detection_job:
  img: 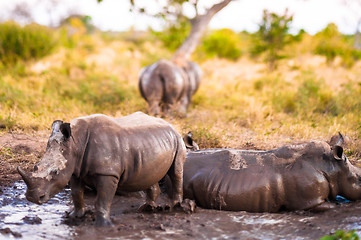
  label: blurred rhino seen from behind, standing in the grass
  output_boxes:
[139,59,202,116]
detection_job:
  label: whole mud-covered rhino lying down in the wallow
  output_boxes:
[183,135,361,212]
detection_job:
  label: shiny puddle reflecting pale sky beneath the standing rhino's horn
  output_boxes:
[0,182,73,239]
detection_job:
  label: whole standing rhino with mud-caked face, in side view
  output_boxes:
[18,112,186,226]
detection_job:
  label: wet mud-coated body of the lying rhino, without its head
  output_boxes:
[184,143,329,212]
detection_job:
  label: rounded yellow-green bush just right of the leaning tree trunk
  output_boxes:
[202,29,241,60]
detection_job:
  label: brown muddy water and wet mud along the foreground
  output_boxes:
[0,182,361,240]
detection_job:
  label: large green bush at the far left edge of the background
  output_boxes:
[0,22,56,65]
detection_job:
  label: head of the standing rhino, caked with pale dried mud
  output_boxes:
[17,120,74,204]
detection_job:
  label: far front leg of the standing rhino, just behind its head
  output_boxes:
[69,176,85,218]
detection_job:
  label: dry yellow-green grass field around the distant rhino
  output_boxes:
[0,28,361,161]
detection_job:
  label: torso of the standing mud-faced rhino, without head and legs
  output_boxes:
[71,112,185,191]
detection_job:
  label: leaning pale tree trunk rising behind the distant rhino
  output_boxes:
[172,0,232,67]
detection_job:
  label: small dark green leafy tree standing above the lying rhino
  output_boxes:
[251,10,293,70]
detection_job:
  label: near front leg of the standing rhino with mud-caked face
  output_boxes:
[95,175,118,226]
